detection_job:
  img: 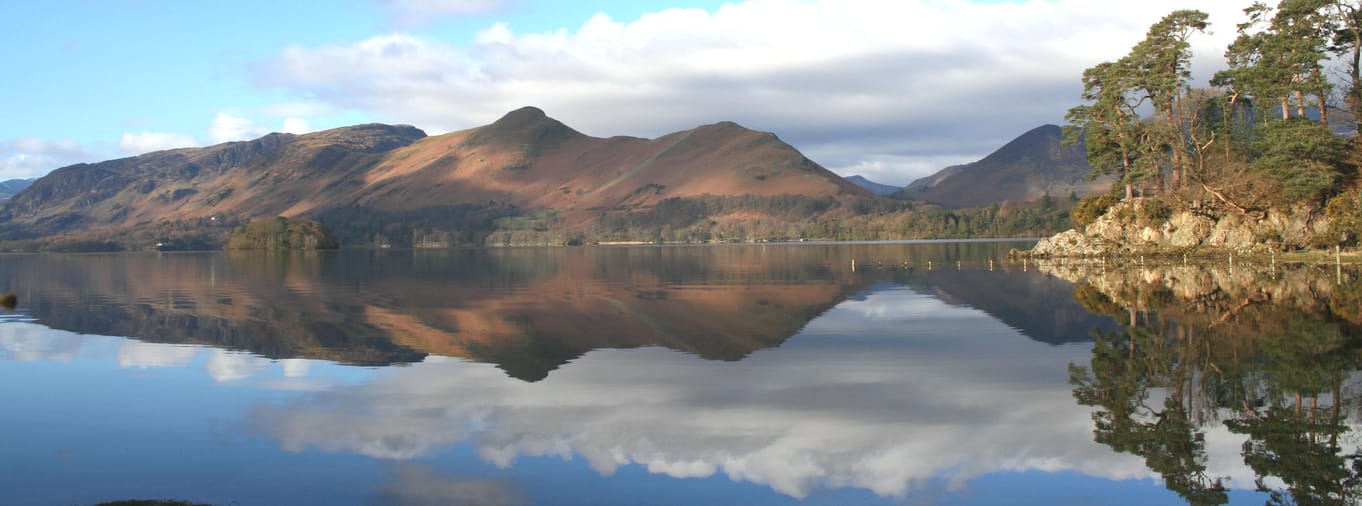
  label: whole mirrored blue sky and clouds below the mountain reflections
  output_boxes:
[0,243,1307,505]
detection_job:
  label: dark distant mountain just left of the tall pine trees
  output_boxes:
[903,125,1111,208]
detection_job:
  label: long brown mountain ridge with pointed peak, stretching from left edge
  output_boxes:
[0,107,870,245]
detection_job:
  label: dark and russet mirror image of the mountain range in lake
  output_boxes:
[0,243,1089,381]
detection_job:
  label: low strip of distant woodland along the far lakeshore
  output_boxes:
[319,195,1079,248]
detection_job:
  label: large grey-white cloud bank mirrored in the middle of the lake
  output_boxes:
[253,290,1176,496]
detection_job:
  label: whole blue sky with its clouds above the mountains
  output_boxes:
[0,0,1250,185]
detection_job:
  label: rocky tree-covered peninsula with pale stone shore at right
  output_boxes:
[1027,3,1362,257]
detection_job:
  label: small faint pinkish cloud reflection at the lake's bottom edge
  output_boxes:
[373,464,530,506]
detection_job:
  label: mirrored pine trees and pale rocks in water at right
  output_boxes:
[1046,265,1362,505]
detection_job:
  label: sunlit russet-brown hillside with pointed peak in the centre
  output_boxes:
[332,107,868,223]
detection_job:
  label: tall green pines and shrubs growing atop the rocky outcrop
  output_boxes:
[1066,0,1362,248]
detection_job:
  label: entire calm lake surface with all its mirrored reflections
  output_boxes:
[0,241,1362,505]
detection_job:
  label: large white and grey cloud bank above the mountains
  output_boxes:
[259,0,1244,182]
